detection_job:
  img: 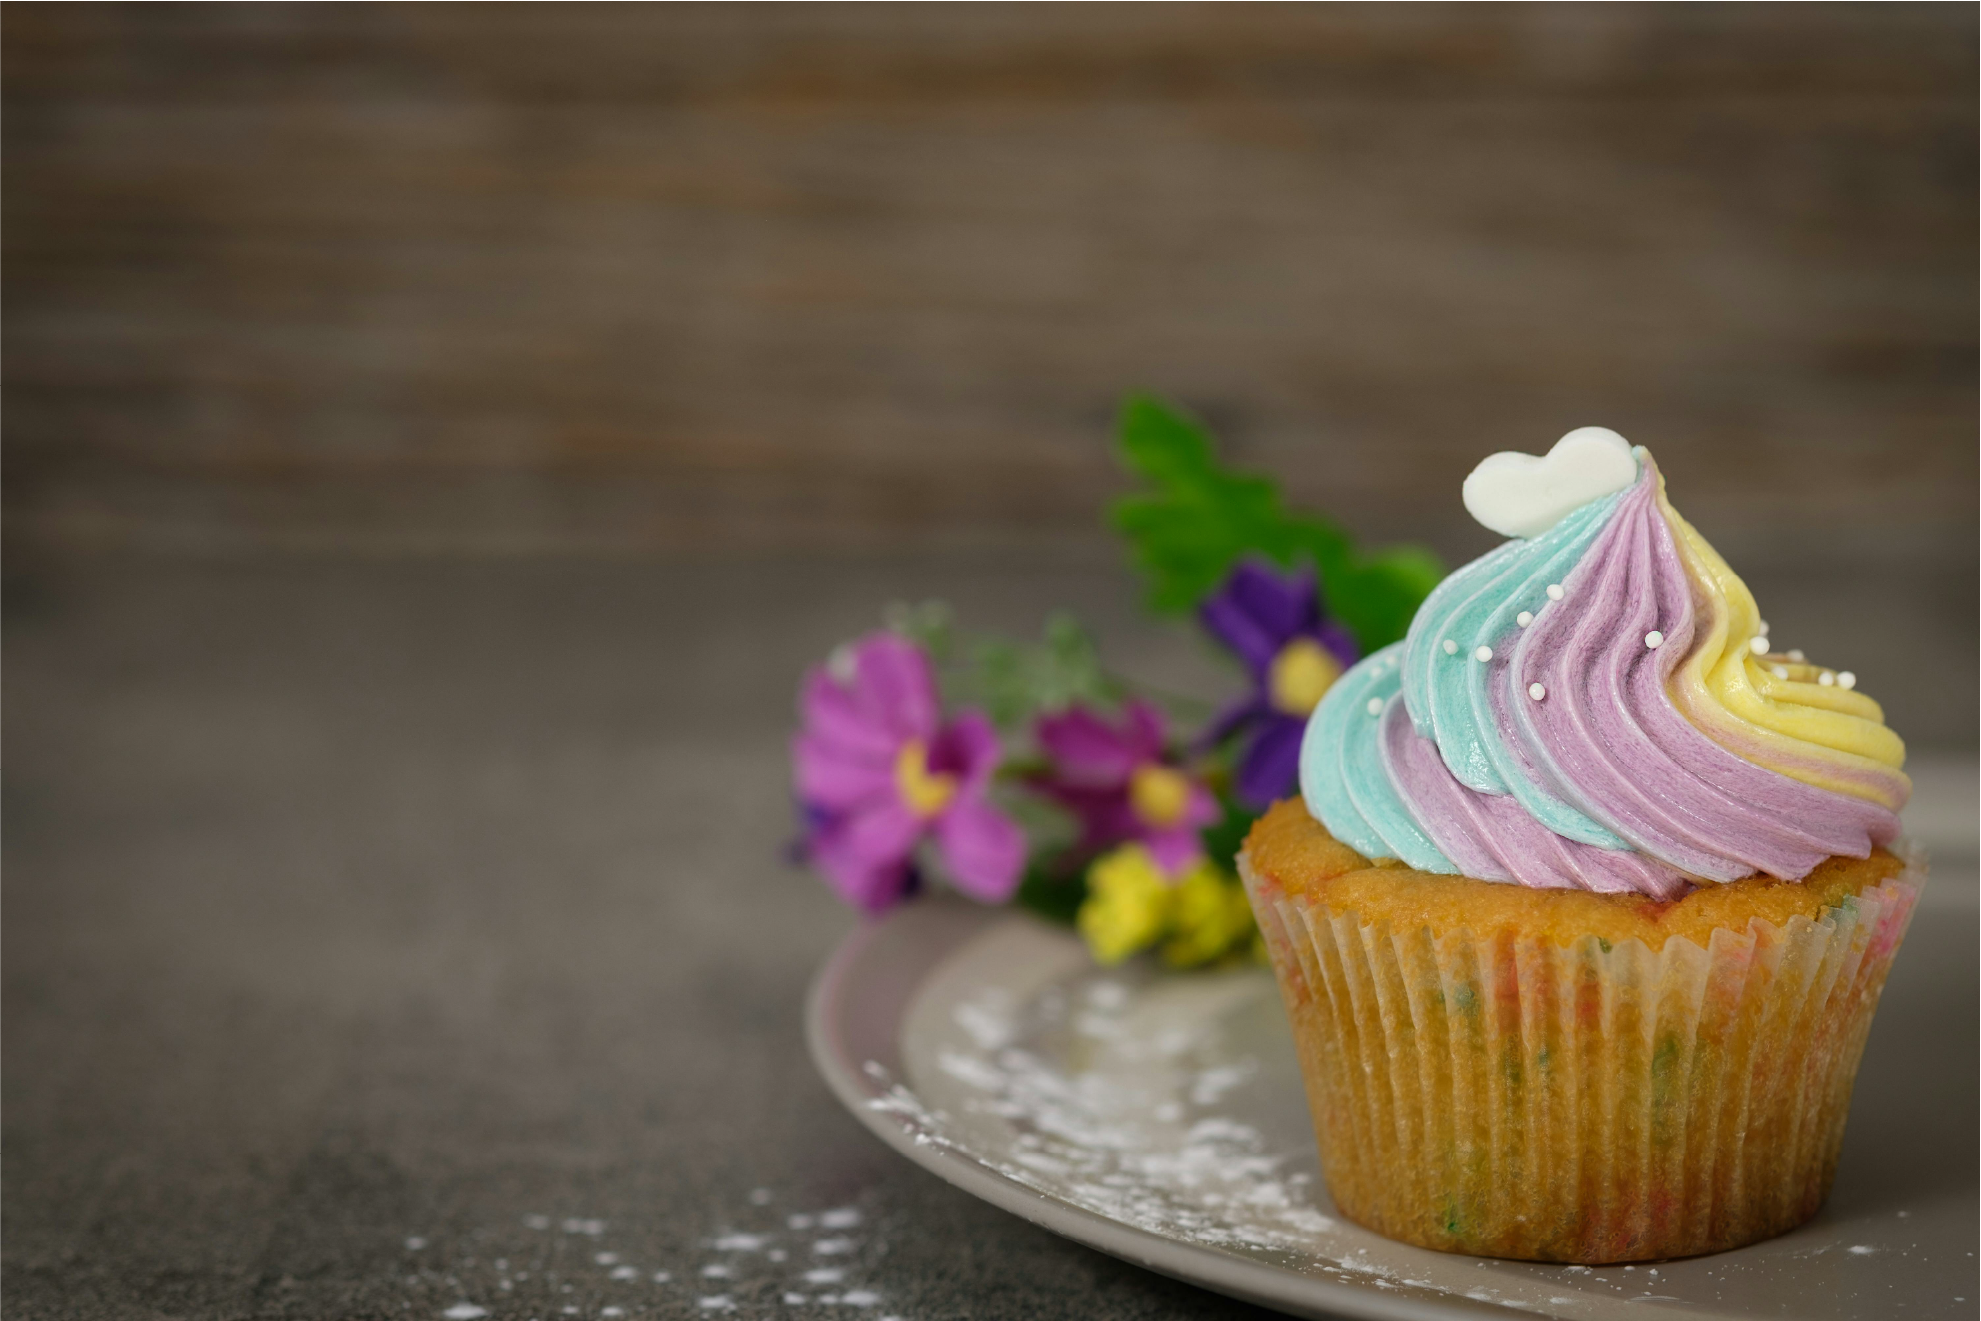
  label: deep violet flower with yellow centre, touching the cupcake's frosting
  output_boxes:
[1197,560,1361,810]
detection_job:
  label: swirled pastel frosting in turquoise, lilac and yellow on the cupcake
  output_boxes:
[1300,442,1912,897]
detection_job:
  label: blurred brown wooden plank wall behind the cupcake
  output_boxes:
[0,4,1977,625]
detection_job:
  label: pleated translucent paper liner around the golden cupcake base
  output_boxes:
[1238,858,1924,1264]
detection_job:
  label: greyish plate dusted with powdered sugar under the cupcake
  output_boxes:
[806,875,1977,1321]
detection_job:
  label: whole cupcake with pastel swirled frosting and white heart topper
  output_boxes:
[1240,428,1924,1264]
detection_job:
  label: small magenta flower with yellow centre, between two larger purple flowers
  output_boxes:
[1032,701,1218,875]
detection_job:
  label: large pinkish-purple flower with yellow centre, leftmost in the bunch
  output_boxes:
[790,634,1024,911]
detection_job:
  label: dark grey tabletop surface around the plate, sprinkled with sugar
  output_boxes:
[0,559,1973,1321]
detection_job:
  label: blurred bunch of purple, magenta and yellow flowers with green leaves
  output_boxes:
[790,396,1442,968]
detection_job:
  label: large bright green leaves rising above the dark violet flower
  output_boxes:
[1109,394,1444,652]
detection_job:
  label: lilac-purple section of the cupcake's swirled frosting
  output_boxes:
[1377,457,1900,897]
